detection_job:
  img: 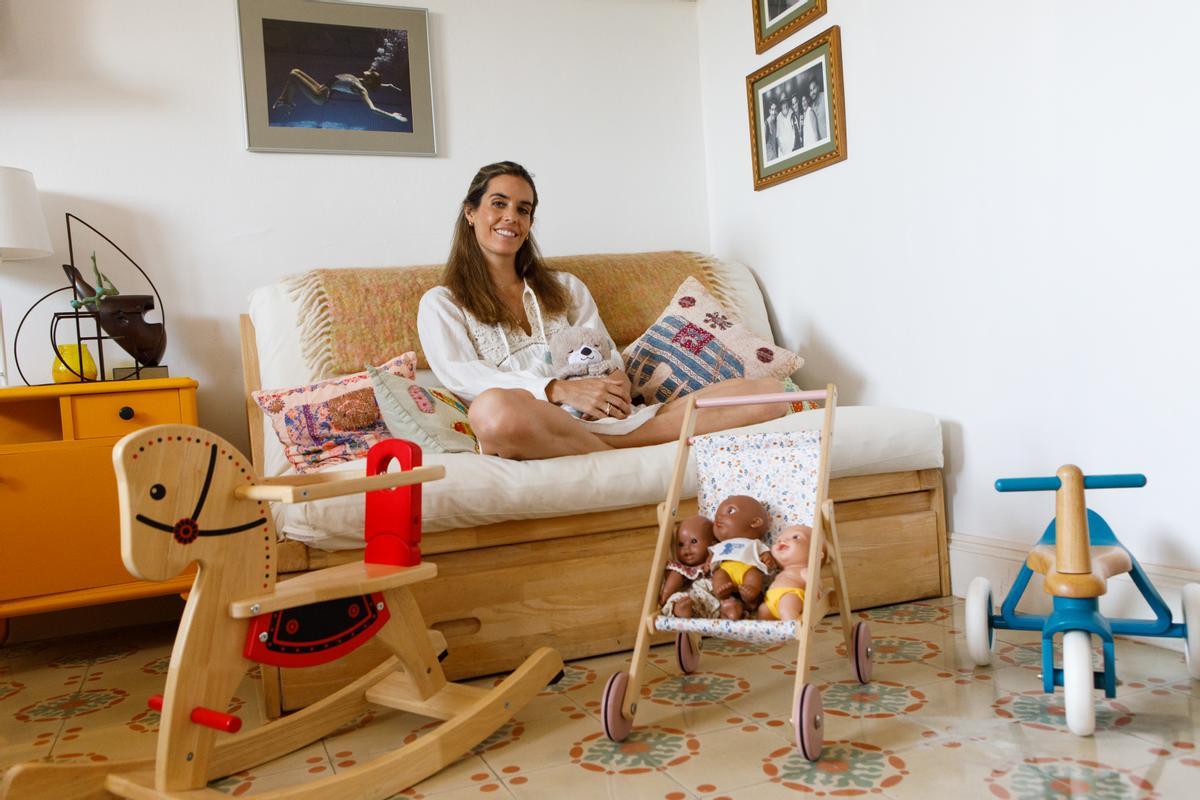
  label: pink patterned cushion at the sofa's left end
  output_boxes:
[253,353,416,473]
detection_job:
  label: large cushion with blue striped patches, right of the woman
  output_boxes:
[622,277,804,403]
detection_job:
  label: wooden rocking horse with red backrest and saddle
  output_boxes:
[0,425,563,800]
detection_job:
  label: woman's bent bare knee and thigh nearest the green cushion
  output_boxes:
[467,389,614,459]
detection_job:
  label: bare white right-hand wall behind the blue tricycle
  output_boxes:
[697,0,1200,567]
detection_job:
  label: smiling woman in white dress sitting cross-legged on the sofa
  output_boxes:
[416,161,785,459]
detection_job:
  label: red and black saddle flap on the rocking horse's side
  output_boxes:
[244,593,390,667]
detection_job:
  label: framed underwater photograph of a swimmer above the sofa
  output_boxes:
[238,0,437,156]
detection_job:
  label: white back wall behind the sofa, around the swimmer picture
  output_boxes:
[0,0,708,444]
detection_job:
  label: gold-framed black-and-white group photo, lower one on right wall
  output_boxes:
[746,25,846,191]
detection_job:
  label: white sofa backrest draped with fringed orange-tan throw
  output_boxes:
[244,252,774,475]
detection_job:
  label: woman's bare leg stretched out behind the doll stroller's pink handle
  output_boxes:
[599,378,787,447]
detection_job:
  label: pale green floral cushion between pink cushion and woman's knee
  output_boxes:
[367,367,479,452]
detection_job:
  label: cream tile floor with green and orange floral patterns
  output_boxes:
[0,599,1200,800]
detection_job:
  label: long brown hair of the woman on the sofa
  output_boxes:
[442,161,570,327]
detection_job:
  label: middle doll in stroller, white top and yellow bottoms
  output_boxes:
[708,494,775,619]
